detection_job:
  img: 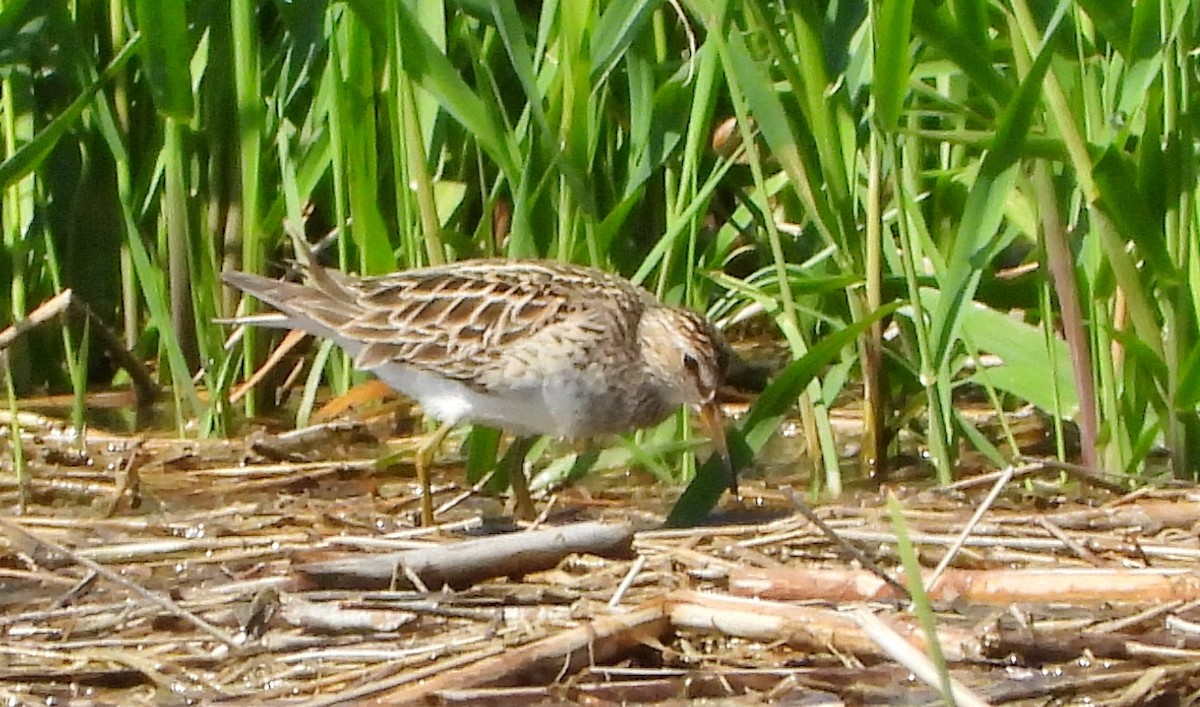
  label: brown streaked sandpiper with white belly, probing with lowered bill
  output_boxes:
[224,259,736,525]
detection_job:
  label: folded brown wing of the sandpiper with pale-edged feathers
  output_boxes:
[296,260,649,389]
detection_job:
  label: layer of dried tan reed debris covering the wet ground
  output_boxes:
[0,415,1200,705]
